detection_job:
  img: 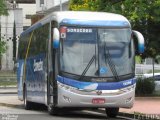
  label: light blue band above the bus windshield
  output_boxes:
[61,19,131,27]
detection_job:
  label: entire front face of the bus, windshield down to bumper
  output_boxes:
[57,19,135,107]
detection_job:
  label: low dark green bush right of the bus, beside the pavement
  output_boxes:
[136,78,155,96]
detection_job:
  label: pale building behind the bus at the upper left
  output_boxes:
[0,0,36,70]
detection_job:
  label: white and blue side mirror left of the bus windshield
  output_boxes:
[53,28,60,49]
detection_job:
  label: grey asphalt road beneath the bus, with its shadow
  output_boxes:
[0,94,133,120]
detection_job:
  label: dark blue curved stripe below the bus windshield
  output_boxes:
[57,76,136,90]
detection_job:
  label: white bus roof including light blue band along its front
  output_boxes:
[21,11,131,35]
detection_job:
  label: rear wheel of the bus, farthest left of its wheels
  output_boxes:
[23,87,32,110]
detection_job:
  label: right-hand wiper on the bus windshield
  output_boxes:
[104,43,119,81]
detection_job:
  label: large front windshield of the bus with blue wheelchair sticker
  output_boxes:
[60,27,134,80]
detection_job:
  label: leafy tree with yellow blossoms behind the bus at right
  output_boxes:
[70,0,160,58]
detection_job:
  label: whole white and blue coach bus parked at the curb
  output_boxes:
[17,11,144,117]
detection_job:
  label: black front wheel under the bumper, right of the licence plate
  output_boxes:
[106,108,119,118]
